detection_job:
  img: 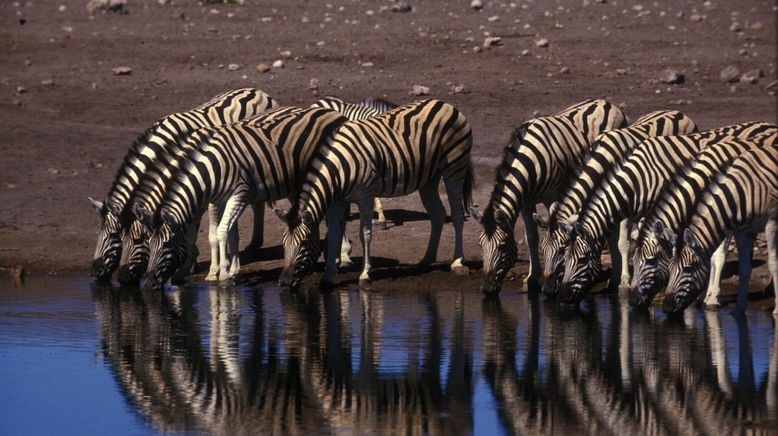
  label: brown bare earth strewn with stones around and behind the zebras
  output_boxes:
[0,0,778,305]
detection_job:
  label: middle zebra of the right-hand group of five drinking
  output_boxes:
[558,122,775,305]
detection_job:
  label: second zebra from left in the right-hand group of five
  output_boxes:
[533,111,697,296]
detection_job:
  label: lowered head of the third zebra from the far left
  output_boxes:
[148,211,188,288]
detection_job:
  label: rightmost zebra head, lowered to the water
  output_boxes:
[662,228,710,315]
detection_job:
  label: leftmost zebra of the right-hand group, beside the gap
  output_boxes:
[471,100,627,294]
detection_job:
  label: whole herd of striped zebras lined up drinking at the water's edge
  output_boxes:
[90,88,778,315]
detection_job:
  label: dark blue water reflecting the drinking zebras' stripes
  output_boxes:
[0,278,778,435]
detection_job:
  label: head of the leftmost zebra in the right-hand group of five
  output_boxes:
[470,208,518,295]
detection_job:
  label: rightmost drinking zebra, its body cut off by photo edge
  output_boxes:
[662,147,778,317]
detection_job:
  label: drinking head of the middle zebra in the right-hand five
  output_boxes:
[557,222,602,305]
